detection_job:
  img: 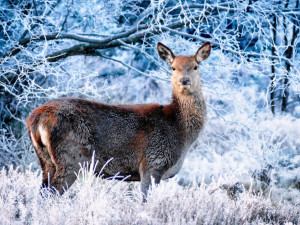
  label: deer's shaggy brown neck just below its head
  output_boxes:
[173,89,206,142]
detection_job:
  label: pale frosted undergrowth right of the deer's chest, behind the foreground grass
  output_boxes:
[178,114,300,206]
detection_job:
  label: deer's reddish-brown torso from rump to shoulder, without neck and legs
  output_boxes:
[27,98,183,180]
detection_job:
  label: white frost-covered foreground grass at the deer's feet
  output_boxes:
[0,163,300,224]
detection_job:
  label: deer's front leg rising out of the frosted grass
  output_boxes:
[139,159,163,202]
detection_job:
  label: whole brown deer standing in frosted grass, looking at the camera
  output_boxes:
[26,42,211,202]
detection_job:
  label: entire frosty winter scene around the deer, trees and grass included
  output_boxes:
[0,0,300,225]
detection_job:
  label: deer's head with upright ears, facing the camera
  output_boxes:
[157,42,211,95]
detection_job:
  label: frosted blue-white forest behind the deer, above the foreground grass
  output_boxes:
[0,0,300,224]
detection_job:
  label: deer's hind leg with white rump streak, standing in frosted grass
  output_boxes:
[36,123,91,194]
